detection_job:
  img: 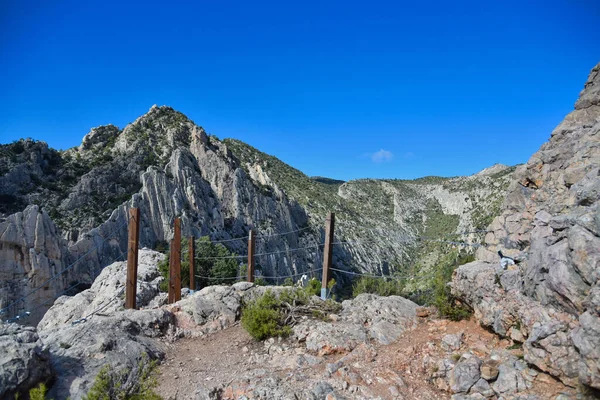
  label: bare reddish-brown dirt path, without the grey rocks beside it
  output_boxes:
[157,319,572,400]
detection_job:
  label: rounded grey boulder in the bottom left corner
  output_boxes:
[0,324,52,398]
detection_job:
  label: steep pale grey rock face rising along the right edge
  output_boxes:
[453,64,600,390]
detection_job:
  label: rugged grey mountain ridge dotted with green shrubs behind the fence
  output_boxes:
[0,106,514,321]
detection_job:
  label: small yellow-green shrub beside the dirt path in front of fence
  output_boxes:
[242,290,291,340]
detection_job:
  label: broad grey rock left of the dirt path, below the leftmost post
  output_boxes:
[40,310,168,399]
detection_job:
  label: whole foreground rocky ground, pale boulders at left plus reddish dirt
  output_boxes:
[0,249,584,400]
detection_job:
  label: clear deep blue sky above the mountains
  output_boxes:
[0,0,600,179]
